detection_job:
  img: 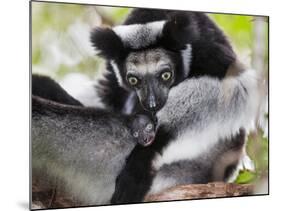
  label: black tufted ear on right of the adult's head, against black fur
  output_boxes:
[161,12,200,50]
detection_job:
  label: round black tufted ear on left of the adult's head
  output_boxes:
[91,27,124,60]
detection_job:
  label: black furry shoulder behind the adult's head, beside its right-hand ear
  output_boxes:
[164,12,236,78]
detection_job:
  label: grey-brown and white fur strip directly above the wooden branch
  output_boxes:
[144,129,245,196]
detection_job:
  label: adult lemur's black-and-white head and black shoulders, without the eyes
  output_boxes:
[91,9,236,113]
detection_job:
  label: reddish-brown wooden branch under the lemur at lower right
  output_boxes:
[145,182,253,201]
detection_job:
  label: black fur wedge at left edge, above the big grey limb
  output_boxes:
[32,74,82,106]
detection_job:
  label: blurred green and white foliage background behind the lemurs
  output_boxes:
[32,2,268,191]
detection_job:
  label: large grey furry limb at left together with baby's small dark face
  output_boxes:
[31,96,155,208]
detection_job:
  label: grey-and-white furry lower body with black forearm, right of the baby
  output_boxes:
[112,67,259,203]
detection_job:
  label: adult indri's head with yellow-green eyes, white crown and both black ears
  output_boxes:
[88,11,198,113]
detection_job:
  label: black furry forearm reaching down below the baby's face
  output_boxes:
[111,125,173,204]
